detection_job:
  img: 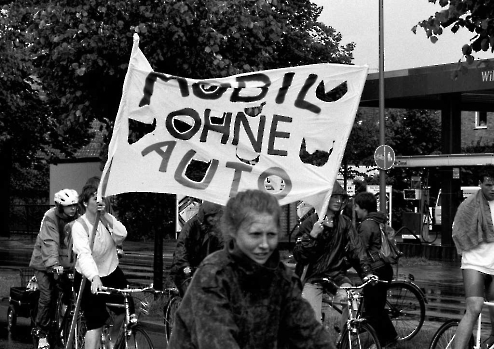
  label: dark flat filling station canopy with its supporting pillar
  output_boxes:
[360,59,494,246]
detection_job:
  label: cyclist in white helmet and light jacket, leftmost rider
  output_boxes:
[29,189,79,349]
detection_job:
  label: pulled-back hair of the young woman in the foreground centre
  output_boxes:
[221,190,281,241]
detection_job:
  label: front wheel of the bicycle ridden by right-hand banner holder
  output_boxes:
[338,322,381,349]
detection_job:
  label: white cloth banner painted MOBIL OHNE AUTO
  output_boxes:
[99,37,367,212]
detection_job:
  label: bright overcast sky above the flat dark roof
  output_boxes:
[312,0,494,72]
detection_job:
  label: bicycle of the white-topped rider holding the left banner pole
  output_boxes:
[98,285,161,349]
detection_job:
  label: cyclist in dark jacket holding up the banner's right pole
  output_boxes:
[293,181,370,326]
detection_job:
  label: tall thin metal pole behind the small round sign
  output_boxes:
[379,0,386,212]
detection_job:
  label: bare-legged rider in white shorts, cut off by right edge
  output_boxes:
[453,165,494,349]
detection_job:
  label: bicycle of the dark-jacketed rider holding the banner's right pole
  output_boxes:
[313,278,386,349]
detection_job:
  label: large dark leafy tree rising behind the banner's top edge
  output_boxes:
[0,0,354,237]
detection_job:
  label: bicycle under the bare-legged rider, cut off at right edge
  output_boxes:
[429,301,494,349]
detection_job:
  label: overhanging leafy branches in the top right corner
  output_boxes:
[412,0,494,69]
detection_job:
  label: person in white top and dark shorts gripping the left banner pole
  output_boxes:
[72,185,133,349]
